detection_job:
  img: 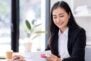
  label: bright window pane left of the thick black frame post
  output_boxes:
[0,0,11,57]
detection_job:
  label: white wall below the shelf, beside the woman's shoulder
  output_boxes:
[75,16,91,45]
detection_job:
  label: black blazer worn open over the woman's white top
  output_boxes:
[46,28,86,61]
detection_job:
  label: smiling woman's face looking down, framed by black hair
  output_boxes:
[52,8,69,29]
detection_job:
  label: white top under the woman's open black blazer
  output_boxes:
[58,28,70,59]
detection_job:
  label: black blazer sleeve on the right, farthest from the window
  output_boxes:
[62,29,86,61]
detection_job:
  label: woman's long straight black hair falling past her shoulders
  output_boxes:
[49,1,79,49]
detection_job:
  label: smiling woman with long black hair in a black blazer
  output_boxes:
[46,1,86,61]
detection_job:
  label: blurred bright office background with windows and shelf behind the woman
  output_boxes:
[0,0,91,60]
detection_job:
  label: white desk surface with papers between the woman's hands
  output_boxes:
[0,51,50,61]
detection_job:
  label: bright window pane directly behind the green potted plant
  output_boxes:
[19,0,45,52]
